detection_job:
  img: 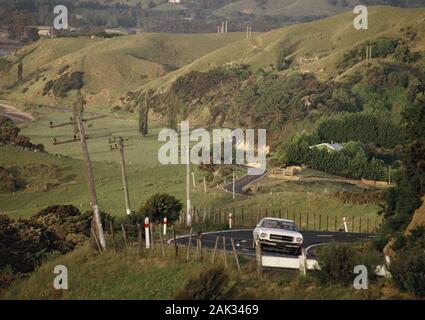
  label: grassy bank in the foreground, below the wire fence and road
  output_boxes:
[0,242,403,300]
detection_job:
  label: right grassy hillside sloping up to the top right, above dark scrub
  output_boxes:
[146,6,425,92]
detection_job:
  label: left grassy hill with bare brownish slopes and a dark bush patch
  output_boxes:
[0,33,245,110]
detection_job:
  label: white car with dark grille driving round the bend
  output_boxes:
[253,218,304,255]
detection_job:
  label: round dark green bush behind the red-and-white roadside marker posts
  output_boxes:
[138,193,183,223]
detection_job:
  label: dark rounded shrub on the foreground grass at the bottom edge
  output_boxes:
[175,266,234,300]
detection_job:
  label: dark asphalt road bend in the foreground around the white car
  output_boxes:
[171,229,374,258]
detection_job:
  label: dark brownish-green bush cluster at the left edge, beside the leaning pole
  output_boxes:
[0,205,110,287]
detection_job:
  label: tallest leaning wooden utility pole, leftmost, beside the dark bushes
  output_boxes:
[76,115,106,250]
